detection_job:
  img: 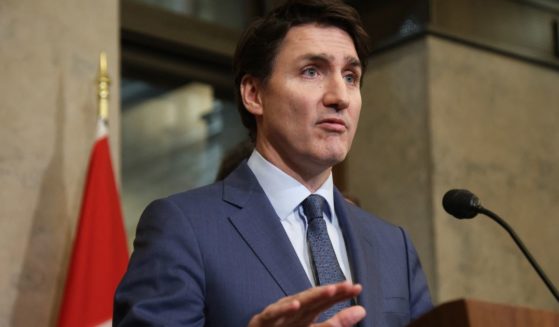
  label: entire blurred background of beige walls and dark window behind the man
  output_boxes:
[0,0,559,326]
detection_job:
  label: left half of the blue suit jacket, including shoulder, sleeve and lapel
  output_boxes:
[113,164,311,326]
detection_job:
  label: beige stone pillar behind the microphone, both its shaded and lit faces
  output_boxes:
[346,36,559,309]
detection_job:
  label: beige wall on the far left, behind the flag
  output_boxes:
[0,0,119,326]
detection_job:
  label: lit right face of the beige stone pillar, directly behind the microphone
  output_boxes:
[428,38,559,309]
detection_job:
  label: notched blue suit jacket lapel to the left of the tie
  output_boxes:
[223,162,312,295]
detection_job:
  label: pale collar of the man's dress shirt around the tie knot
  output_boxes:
[247,150,334,220]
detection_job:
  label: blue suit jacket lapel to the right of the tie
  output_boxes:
[334,189,383,327]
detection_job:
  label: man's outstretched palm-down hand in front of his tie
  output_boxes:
[249,282,364,327]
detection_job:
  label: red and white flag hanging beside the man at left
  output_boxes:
[58,119,128,327]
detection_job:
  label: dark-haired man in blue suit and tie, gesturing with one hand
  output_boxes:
[113,0,431,327]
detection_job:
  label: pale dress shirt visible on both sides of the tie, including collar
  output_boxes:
[247,150,352,285]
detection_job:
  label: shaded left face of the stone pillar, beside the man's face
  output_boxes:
[345,40,436,298]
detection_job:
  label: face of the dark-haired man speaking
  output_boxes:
[247,24,361,179]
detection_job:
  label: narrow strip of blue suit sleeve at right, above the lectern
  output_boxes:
[400,228,433,321]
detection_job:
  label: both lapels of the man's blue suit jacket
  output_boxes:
[223,162,383,327]
